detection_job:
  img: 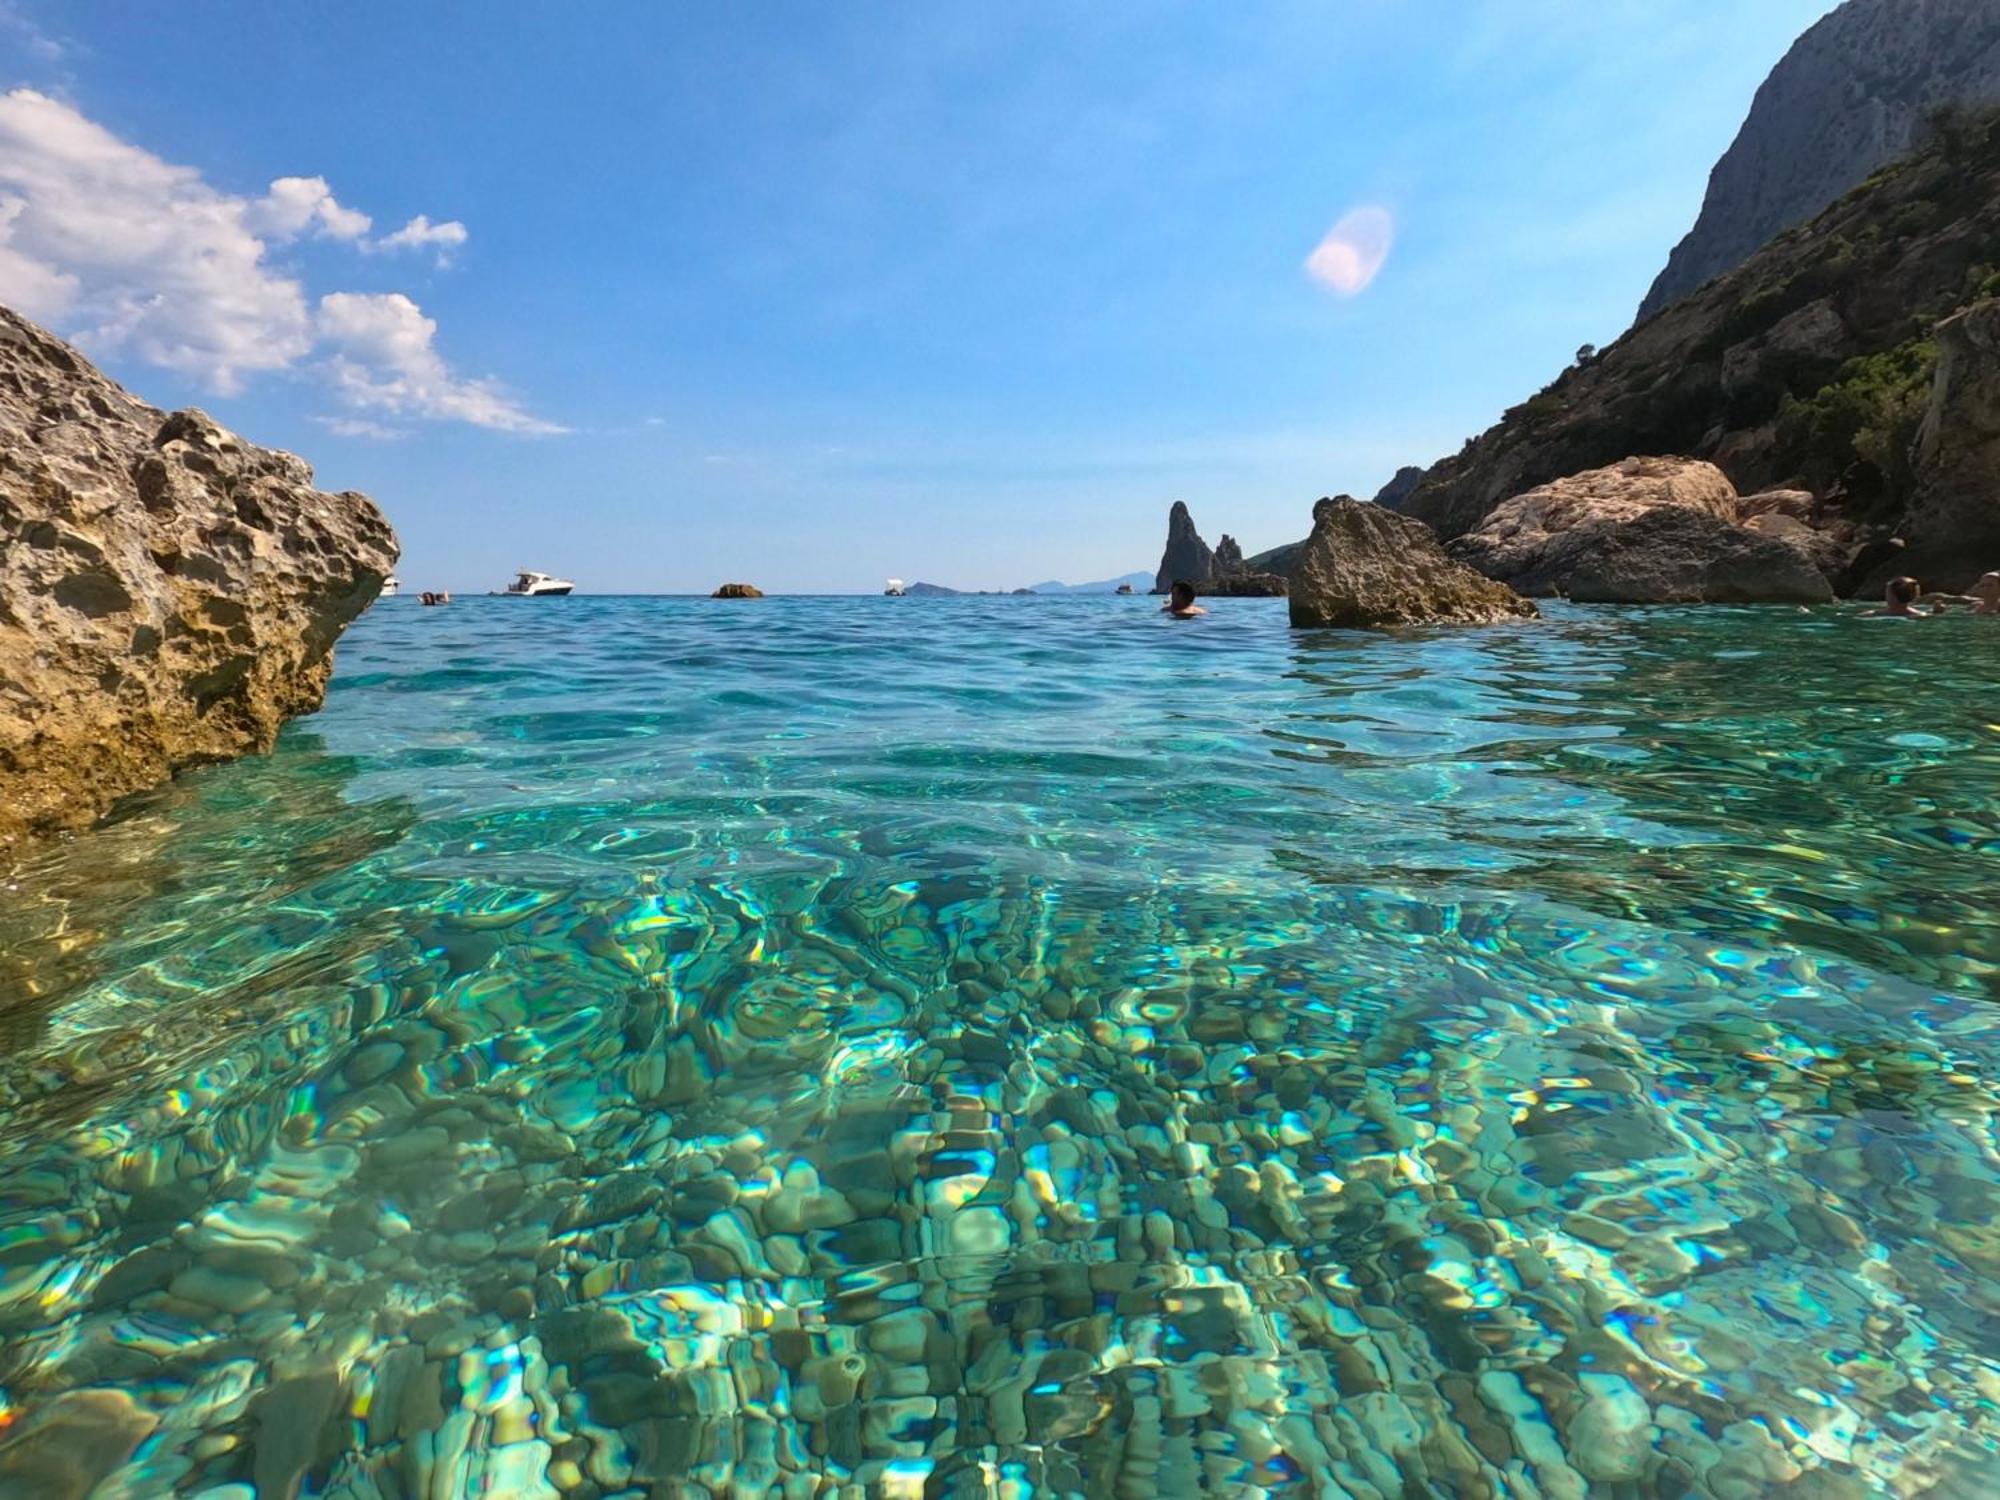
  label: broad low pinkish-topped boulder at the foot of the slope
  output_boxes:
[1448,458,1834,604]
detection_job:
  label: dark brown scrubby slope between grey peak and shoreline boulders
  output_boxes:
[1400,118,2000,594]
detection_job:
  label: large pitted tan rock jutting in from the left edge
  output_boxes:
[0,308,396,848]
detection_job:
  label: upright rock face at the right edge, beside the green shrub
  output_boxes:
[1898,298,2000,590]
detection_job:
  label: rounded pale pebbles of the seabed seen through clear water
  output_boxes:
[0,878,2000,1500]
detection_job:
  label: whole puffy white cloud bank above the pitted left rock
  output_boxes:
[0,88,562,436]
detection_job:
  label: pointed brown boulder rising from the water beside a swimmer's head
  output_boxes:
[1292,496,1536,630]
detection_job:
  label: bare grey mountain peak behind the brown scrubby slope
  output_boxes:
[1638,0,2000,320]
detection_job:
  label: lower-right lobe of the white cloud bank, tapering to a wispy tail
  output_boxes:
[318,292,564,434]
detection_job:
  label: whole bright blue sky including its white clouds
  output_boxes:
[0,0,1832,592]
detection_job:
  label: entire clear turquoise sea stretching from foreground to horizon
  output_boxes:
[0,598,2000,1500]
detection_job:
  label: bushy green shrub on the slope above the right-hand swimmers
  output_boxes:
[1778,338,1938,500]
